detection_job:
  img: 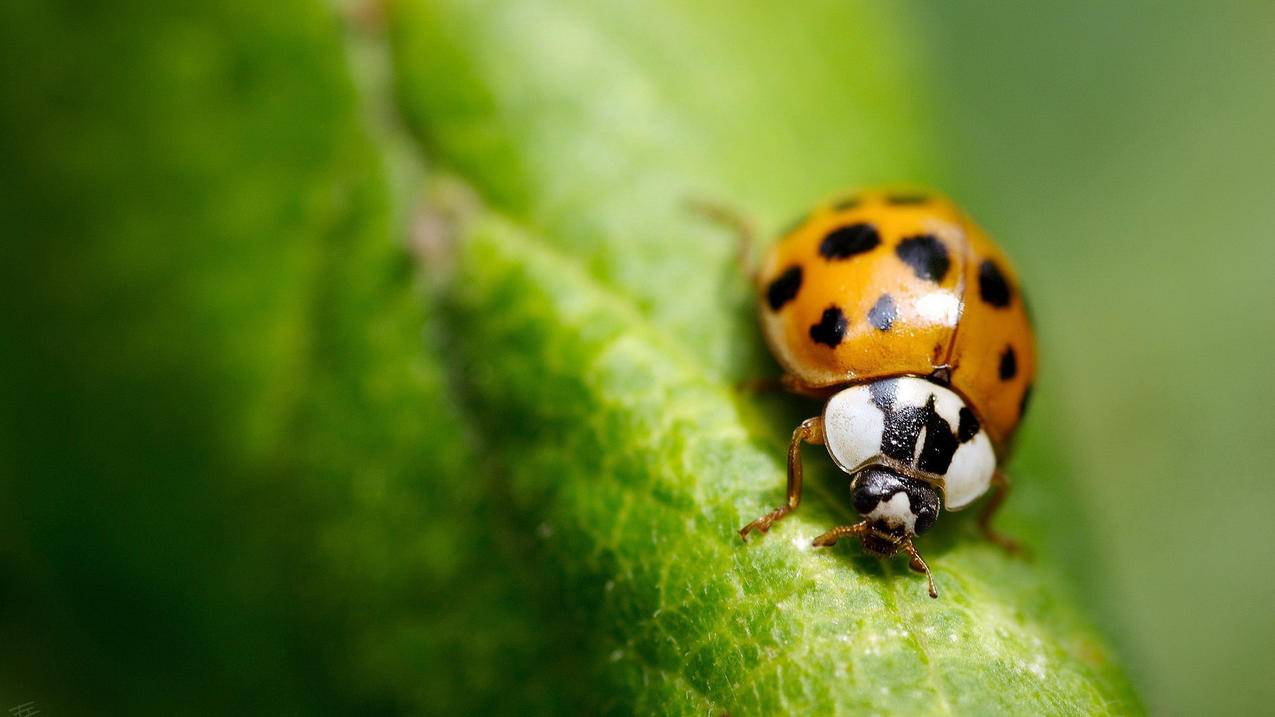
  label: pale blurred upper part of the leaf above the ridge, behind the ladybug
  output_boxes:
[391,1,933,373]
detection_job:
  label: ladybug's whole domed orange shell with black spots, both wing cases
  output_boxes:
[757,193,1037,453]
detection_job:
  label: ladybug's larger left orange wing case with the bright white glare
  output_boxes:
[757,194,966,388]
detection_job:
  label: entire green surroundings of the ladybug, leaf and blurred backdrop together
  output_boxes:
[0,0,1275,714]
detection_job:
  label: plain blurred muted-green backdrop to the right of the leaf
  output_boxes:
[915,3,1275,714]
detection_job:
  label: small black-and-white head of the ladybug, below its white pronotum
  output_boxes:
[850,466,941,558]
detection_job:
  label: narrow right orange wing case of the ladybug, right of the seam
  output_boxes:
[950,221,1037,453]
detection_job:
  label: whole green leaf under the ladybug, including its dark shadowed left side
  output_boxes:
[0,0,1137,714]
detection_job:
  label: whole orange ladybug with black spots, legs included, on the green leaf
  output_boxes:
[719,191,1037,597]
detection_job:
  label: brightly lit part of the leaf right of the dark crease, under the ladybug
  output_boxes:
[391,1,1140,714]
